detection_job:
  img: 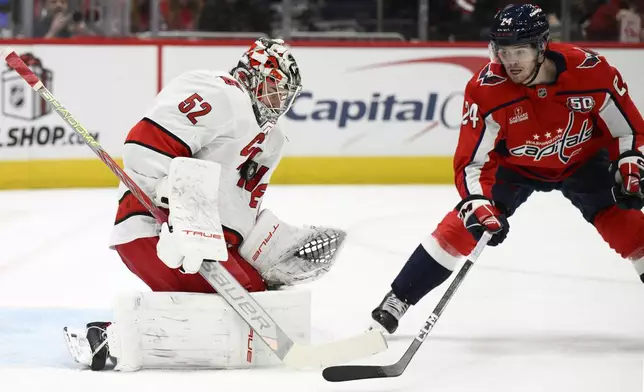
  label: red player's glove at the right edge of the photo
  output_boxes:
[609,151,644,210]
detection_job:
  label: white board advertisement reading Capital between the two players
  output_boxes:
[285,49,488,156]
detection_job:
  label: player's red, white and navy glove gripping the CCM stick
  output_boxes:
[456,195,510,246]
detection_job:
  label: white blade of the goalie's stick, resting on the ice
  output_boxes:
[284,330,387,368]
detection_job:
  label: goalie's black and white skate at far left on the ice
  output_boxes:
[63,321,110,370]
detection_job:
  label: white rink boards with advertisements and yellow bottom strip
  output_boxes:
[0,40,644,188]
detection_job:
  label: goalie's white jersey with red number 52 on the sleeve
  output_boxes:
[110,71,286,246]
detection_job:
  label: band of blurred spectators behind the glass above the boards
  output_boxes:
[7,0,644,42]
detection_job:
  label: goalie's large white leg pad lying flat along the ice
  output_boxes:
[107,290,311,371]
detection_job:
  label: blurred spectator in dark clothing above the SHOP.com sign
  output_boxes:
[34,0,92,38]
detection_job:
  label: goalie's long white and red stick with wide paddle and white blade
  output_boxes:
[0,48,387,367]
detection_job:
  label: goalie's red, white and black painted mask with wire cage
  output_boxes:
[231,38,302,126]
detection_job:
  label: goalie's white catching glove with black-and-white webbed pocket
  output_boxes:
[239,209,346,287]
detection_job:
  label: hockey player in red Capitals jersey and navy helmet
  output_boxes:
[372,4,644,333]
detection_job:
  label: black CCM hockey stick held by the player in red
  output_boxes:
[322,231,492,382]
